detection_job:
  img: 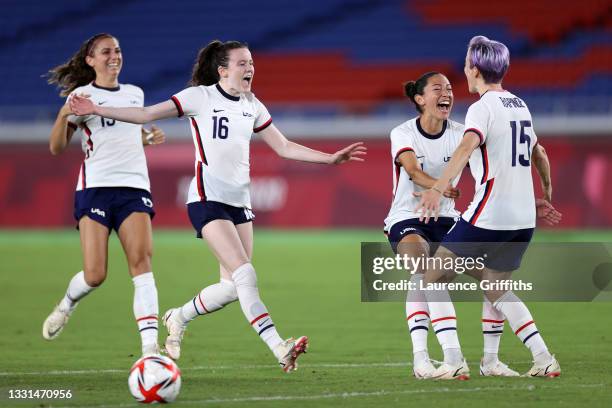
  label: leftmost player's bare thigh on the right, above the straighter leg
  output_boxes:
[117,212,153,276]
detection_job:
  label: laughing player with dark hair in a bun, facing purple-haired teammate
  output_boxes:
[385,72,518,379]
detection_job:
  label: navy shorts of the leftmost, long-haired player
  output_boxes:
[74,187,155,231]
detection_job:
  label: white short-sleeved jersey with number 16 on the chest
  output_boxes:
[172,84,272,208]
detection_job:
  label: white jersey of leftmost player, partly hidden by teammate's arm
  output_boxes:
[68,83,150,191]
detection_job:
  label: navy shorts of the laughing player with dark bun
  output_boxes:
[387,217,455,254]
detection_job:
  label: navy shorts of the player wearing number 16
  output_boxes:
[187,201,255,238]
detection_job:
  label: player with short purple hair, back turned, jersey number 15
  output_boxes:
[417,36,561,379]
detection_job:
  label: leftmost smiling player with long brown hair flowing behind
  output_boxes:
[42,33,164,355]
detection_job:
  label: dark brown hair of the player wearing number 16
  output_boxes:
[189,40,249,86]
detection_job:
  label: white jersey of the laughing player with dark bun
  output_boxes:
[385,118,463,231]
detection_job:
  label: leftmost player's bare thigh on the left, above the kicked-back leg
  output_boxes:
[79,216,110,286]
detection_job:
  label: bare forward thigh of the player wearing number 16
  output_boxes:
[202,220,249,272]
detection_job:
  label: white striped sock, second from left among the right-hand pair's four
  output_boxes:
[424,289,463,365]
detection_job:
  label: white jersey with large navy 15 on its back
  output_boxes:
[463,91,537,230]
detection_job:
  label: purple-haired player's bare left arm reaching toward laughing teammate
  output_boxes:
[414,131,480,223]
